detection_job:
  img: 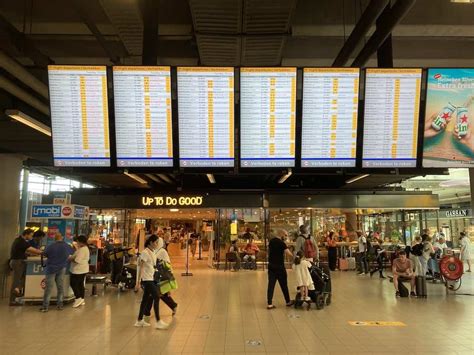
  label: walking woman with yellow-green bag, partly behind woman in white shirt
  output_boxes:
[144,238,178,317]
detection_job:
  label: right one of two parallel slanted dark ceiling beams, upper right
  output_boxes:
[351,0,416,67]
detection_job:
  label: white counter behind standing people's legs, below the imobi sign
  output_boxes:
[23,256,74,302]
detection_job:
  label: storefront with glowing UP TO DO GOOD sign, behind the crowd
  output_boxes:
[38,190,438,264]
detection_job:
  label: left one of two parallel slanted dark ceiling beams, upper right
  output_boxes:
[332,0,390,67]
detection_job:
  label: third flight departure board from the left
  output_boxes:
[178,67,234,168]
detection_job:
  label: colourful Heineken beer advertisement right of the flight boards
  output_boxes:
[423,68,474,168]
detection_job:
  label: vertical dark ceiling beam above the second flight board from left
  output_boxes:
[142,0,160,65]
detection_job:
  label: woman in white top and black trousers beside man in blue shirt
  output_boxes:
[69,235,90,308]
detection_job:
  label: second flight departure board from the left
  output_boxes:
[113,66,173,167]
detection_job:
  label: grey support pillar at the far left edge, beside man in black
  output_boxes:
[0,154,23,297]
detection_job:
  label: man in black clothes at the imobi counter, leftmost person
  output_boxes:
[10,228,41,306]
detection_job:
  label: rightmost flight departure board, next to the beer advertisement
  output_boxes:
[362,68,421,168]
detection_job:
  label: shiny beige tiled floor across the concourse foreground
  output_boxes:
[0,261,474,355]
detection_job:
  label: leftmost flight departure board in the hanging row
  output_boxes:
[48,65,110,167]
